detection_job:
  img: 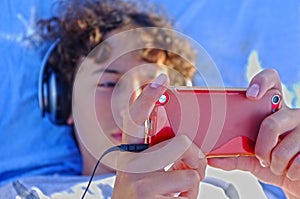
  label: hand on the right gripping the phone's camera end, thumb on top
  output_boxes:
[208,69,300,198]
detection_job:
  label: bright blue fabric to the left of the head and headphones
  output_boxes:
[0,0,81,185]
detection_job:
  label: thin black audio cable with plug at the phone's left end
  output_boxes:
[81,144,149,199]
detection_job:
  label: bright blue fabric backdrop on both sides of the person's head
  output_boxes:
[0,0,300,198]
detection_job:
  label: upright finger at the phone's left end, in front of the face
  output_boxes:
[122,74,169,143]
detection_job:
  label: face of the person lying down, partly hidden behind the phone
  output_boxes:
[72,28,188,166]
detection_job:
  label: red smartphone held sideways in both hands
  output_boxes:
[145,87,281,158]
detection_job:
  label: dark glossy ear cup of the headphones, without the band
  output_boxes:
[45,71,71,125]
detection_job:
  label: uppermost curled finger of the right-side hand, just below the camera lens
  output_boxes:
[255,108,299,166]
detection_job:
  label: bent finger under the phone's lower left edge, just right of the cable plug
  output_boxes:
[119,135,206,174]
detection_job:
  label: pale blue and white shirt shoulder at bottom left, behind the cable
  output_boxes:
[0,174,115,199]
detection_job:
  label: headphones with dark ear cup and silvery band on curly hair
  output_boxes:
[38,39,71,125]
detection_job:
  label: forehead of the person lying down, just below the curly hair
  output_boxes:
[85,25,166,71]
